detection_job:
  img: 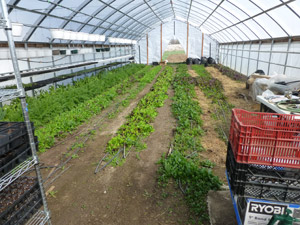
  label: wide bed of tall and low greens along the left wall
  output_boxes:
[4,65,150,151]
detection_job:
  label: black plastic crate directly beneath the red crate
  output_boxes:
[226,142,300,203]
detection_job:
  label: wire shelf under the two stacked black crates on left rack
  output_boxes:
[0,159,35,191]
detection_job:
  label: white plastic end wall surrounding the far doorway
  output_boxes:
[135,20,218,64]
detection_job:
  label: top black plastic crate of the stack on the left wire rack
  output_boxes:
[0,122,34,156]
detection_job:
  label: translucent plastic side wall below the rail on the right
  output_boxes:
[219,42,300,76]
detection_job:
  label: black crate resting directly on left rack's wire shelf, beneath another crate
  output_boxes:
[0,138,38,177]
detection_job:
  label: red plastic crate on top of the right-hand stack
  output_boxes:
[229,109,300,168]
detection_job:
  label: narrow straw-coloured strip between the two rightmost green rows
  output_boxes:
[189,70,227,181]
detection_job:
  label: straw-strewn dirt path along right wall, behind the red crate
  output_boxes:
[206,67,259,112]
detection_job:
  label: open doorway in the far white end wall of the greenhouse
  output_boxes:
[163,39,186,63]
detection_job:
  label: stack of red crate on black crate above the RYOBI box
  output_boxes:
[226,109,300,224]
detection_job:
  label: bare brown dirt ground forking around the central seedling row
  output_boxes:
[41,71,189,225]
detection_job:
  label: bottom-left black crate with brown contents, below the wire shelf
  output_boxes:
[0,177,42,225]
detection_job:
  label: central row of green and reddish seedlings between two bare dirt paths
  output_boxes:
[102,66,173,168]
